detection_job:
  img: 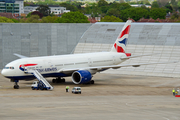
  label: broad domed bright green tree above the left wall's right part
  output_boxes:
[55,12,89,23]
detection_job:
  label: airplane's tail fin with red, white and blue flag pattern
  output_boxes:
[110,20,132,53]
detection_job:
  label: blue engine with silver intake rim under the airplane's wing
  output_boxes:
[72,70,92,84]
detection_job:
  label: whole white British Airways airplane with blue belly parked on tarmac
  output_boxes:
[1,20,176,90]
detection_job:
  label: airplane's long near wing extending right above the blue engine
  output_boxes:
[58,61,178,73]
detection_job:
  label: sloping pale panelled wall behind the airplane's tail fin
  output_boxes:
[75,23,180,77]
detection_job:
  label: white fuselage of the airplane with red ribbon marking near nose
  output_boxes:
[2,52,126,80]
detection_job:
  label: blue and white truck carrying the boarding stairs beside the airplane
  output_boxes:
[31,81,48,90]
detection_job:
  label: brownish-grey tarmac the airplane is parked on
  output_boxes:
[0,73,180,120]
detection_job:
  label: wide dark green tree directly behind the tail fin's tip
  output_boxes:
[120,7,149,21]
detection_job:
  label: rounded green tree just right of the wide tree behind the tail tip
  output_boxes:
[150,8,166,20]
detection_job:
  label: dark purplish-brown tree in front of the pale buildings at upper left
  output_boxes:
[36,5,51,16]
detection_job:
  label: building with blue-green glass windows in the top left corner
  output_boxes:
[0,0,24,16]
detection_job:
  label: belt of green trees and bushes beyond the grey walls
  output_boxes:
[1,0,180,23]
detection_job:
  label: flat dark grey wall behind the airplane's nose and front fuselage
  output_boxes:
[0,23,92,69]
